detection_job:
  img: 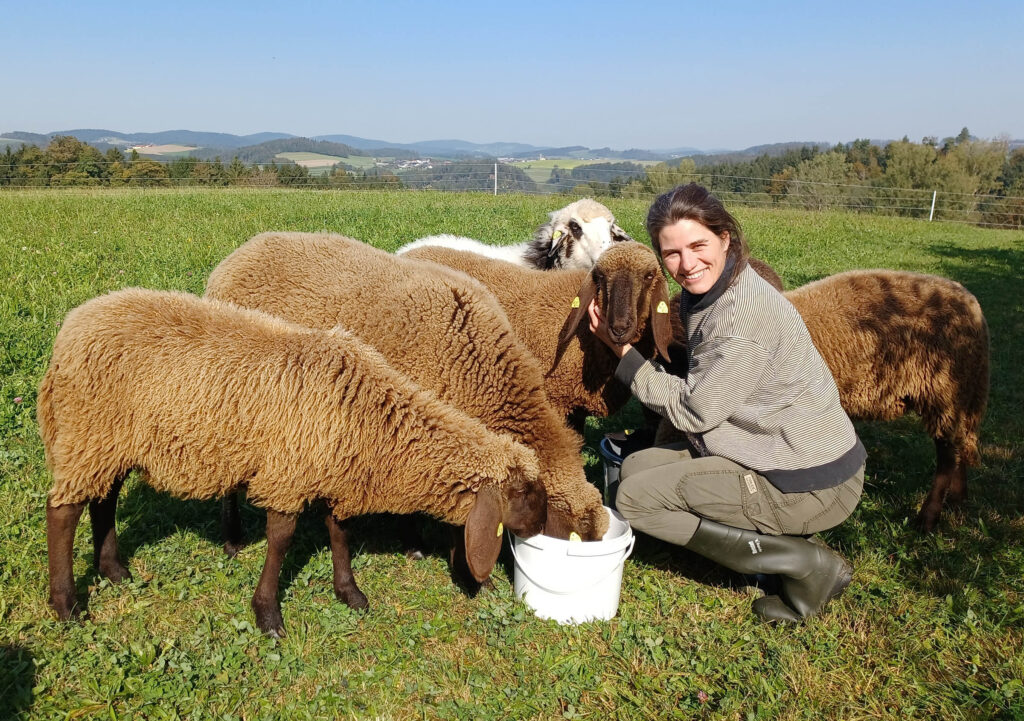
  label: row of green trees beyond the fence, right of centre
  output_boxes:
[552,128,1024,227]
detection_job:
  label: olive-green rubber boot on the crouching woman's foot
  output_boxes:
[685,518,853,623]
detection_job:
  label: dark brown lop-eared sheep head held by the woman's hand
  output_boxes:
[552,243,672,370]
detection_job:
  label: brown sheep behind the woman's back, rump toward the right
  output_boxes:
[658,270,988,532]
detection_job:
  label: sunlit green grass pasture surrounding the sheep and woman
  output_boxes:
[0,188,1024,721]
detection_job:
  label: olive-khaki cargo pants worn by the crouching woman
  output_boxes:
[615,441,864,546]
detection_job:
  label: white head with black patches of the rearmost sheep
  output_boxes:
[526,198,633,269]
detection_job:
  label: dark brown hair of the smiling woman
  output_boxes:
[647,182,751,286]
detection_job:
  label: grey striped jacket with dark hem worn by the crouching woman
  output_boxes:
[615,266,866,492]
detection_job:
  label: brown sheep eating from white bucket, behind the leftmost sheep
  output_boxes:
[206,232,608,540]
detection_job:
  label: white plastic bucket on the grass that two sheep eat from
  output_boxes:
[512,506,636,624]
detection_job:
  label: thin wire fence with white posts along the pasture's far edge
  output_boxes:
[0,159,1024,228]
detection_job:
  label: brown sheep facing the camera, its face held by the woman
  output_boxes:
[408,243,672,416]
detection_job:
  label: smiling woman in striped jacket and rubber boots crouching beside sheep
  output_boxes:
[590,183,866,622]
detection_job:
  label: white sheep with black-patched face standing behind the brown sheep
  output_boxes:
[395,198,633,270]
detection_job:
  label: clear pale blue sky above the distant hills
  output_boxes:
[0,0,1024,150]
